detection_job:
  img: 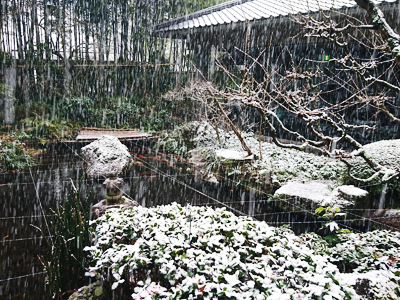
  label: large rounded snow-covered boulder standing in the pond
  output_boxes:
[82,135,133,178]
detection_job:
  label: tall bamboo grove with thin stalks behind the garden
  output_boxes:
[0,0,222,123]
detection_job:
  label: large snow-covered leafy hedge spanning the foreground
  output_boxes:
[85,203,400,300]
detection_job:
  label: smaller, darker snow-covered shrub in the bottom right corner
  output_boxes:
[302,230,400,299]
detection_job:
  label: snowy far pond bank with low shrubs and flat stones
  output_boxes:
[158,122,400,231]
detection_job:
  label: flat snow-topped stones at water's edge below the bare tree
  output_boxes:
[275,180,368,207]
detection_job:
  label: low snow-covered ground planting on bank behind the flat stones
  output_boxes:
[194,122,345,185]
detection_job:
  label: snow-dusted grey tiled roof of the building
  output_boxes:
[153,0,396,32]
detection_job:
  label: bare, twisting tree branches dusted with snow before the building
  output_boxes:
[214,1,400,182]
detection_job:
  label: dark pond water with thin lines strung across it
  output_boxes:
[0,144,394,300]
